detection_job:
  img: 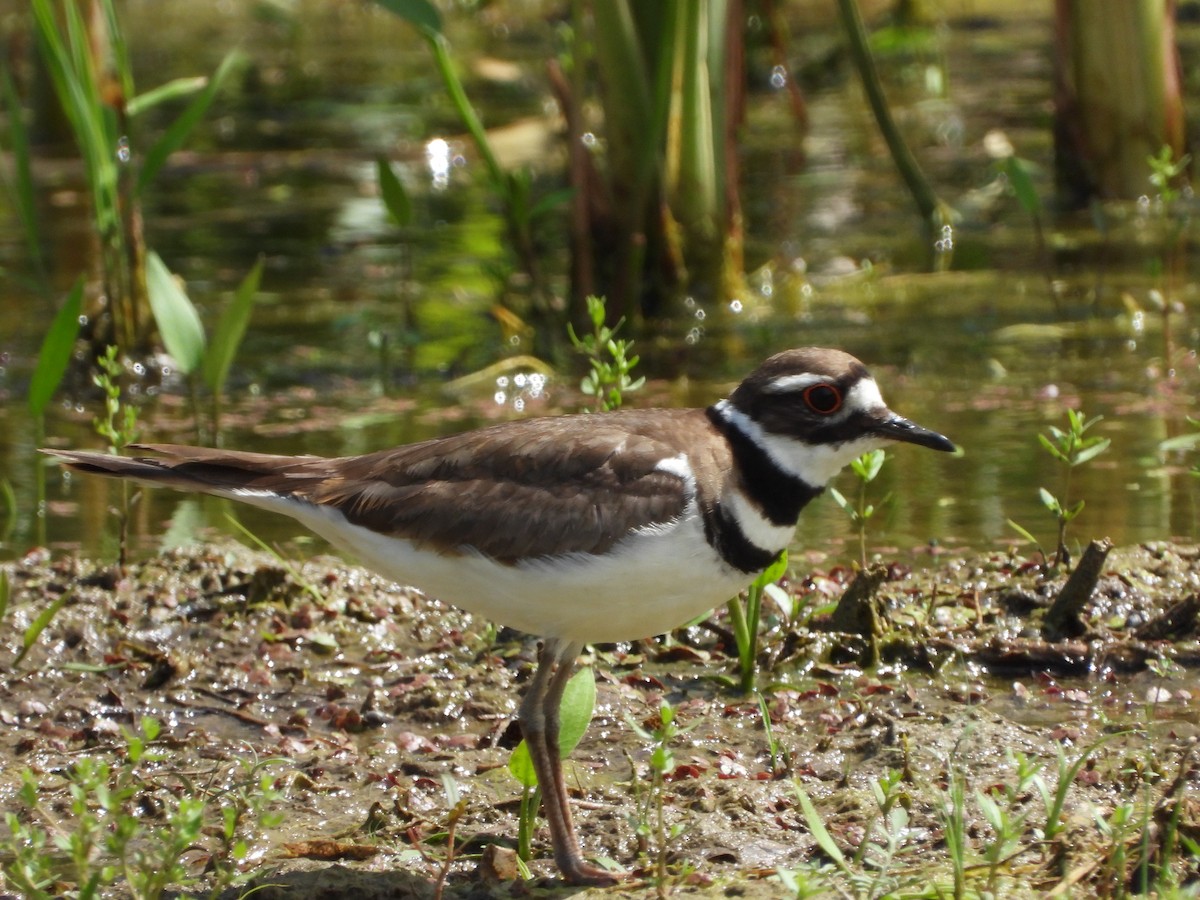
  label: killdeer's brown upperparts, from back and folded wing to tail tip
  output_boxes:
[47,409,727,562]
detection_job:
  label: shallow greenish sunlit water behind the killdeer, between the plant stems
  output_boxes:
[0,0,1200,559]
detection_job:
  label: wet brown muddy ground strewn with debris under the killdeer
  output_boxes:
[0,544,1200,900]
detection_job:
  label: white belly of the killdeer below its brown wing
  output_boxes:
[236,493,751,643]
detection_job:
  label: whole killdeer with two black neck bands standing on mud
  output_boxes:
[39,348,954,884]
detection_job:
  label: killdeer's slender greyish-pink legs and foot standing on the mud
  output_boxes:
[520,638,617,884]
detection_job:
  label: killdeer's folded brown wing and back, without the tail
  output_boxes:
[308,410,708,562]
